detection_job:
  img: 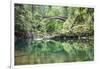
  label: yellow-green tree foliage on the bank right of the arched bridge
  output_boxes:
[62,7,94,35]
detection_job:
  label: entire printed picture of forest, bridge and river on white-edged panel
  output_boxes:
[14,4,94,65]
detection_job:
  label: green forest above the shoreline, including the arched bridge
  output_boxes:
[15,4,94,36]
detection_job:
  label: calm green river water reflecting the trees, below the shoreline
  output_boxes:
[15,39,94,65]
